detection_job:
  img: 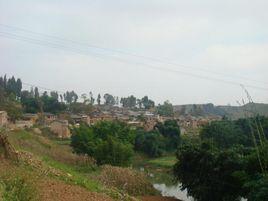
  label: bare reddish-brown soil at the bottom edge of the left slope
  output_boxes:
[39,180,113,201]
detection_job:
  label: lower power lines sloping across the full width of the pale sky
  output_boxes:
[0,24,268,90]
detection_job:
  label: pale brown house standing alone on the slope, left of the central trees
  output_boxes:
[50,120,71,138]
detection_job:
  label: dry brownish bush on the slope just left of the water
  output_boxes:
[99,165,155,196]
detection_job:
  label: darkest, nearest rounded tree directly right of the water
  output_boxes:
[174,144,243,201]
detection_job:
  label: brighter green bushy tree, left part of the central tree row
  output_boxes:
[71,121,135,165]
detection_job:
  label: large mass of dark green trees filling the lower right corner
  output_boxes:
[174,117,268,201]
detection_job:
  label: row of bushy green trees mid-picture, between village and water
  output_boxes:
[71,120,180,166]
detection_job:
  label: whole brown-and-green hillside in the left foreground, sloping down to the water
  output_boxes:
[0,128,180,201]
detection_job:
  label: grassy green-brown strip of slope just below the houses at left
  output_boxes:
[6,130,102,192]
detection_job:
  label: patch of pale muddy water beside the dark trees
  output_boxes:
[154,184,194,201]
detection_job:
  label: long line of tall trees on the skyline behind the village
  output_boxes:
[0,75,173,119]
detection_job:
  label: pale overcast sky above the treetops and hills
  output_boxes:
[0,0,268,105]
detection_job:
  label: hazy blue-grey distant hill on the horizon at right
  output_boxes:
[174,103,268,119]
